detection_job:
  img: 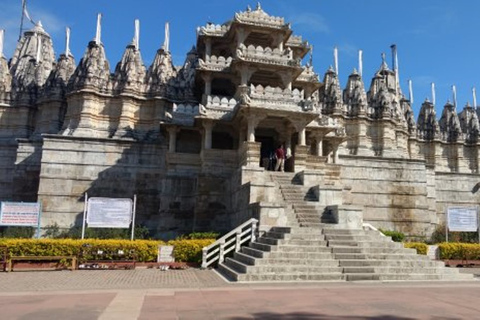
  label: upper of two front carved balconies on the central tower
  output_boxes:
[236,44,300,67]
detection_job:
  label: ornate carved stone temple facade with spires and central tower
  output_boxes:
[0,6,480,237]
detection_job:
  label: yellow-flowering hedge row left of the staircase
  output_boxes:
[0,239,215,262]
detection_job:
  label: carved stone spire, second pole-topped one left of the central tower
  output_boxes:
[113,44,147,93]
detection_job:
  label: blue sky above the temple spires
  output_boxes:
[0,0,480,115]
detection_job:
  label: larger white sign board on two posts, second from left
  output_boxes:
[87,198,132,228]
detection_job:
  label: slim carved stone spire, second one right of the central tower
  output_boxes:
[343,69,367,117]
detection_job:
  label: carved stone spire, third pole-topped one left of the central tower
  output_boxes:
[68,41,111,92]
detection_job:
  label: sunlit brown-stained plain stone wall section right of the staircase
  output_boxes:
[341,156,437,236]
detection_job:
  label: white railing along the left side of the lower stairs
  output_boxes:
[202,218,258,268]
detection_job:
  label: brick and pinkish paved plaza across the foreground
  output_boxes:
[0,269,480,320]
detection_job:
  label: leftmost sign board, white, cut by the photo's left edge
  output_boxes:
[0,202,40,227]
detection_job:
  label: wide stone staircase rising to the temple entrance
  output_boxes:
[218,172,473,282]
